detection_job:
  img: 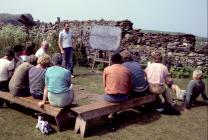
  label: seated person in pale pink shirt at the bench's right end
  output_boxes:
[145,51,174,106]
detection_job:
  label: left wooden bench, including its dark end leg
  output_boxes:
[0,91,69,131]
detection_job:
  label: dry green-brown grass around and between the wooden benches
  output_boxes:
[0,68,208,140]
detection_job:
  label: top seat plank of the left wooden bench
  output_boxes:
[0,92,63,117]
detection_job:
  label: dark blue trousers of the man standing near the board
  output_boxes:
[62,47,74,75]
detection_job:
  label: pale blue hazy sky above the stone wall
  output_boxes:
[0,0,208,37]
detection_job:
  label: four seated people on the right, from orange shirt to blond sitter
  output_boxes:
[103,50,208,111]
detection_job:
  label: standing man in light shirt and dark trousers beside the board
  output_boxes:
[58,23,74,78]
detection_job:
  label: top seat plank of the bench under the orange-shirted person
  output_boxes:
[71,94,156,120]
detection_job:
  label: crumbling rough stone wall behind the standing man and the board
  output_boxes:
[20,19,208,70]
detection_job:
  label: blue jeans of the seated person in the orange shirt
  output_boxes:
[104,94,128,103]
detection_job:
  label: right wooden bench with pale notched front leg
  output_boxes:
[71,94,156,137]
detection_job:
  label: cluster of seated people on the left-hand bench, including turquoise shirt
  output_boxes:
[0,41,74,107]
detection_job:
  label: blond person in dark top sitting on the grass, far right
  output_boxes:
[184,70,208,111]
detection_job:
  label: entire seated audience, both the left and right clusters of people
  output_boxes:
[0,41,208,109]
